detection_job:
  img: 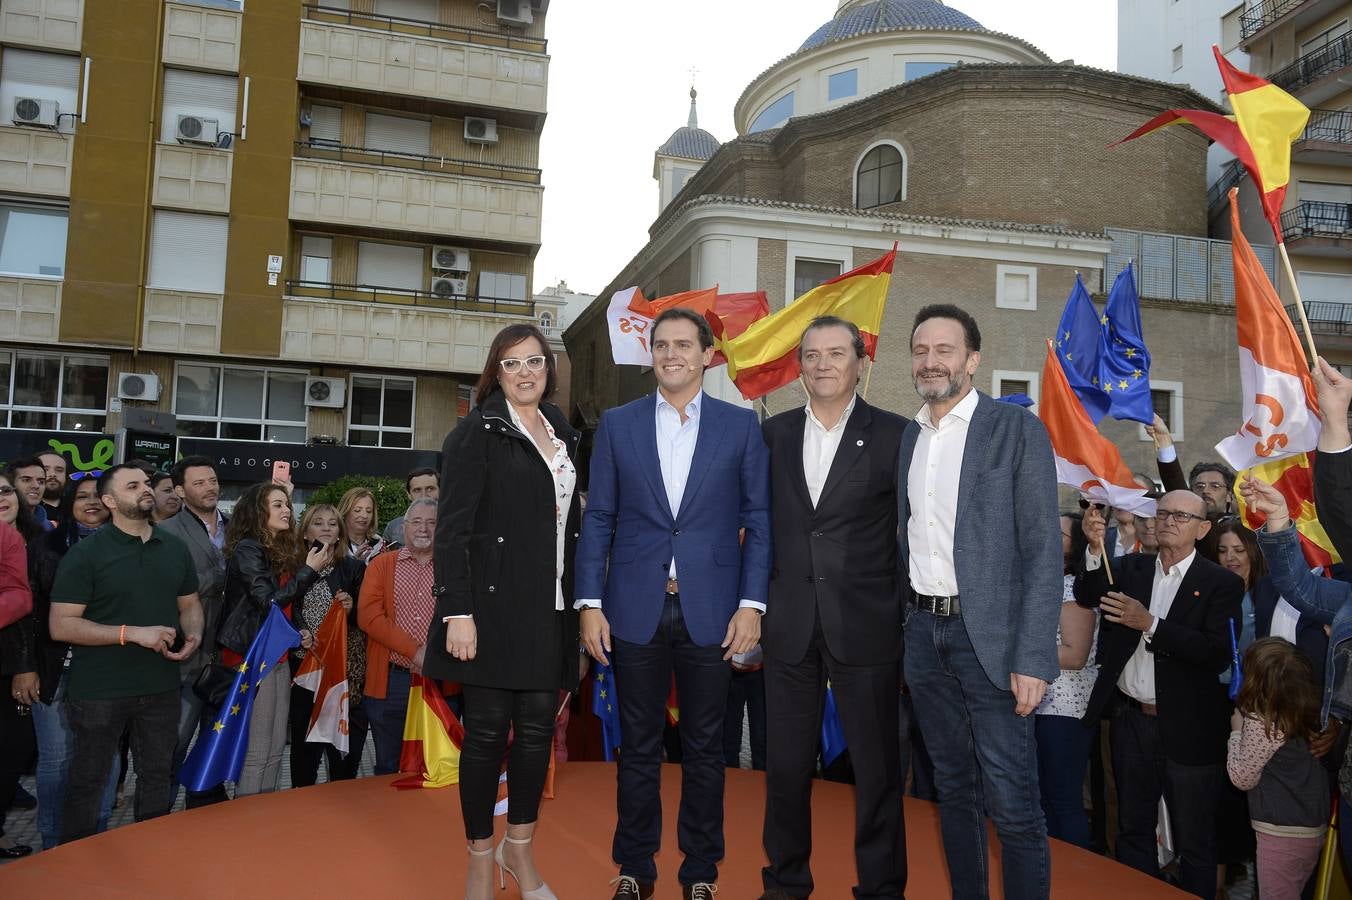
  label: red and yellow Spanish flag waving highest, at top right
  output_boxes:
[1118,45,1310,243]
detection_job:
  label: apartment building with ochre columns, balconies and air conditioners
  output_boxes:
[0,0,549,480]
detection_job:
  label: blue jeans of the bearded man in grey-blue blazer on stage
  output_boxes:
[904,609,1052,900]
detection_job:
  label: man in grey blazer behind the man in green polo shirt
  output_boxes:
[158,457,226,807]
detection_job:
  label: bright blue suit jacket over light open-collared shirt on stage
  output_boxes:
[575,393,771,647]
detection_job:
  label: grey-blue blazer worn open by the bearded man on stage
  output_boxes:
[896,392,1064,691]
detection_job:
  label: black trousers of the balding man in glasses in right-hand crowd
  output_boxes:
[1111,701,1226,897]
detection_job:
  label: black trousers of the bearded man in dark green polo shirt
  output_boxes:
[61,686,178,843]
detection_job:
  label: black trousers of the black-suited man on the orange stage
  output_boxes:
[762,622,906,897]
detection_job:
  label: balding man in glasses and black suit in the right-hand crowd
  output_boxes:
[1075,491,1244,897]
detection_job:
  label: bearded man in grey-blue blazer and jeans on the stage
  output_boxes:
[898,304,1063,900]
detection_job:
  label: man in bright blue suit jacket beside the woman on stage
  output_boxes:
[575,308,771,900]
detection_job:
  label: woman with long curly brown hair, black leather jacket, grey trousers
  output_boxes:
[220,482,333,797]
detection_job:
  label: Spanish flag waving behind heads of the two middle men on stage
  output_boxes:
[706,245,896,400]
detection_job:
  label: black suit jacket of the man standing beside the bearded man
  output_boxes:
[761,397,907,665]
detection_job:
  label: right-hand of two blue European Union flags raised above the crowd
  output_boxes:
[1098,264,1155,424]
